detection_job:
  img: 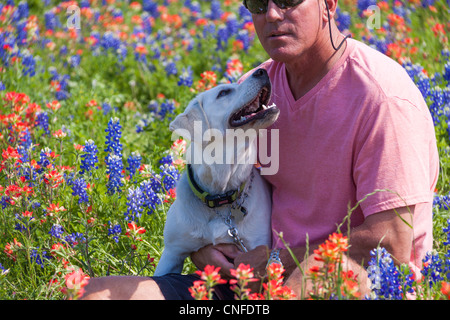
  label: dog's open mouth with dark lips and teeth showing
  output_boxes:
[229,87,275,127]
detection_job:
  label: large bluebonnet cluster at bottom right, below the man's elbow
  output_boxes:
[366,248,412,300]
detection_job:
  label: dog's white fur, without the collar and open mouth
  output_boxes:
[155,72,278,276]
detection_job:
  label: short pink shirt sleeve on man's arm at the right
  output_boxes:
[353,97,436,217]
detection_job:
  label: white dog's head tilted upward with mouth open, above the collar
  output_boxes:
[169,69,280,137]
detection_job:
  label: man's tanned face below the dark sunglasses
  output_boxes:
[252,0,323,62]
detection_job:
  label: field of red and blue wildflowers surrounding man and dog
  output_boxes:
[0,0,450,300]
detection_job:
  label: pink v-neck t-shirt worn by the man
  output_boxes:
[244,39,439,267]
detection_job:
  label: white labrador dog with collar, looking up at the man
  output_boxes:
[155,69,279,276]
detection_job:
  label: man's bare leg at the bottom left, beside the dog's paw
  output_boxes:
[82,276,164,300]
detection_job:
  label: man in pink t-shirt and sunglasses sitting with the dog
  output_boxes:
[81,0,439,299]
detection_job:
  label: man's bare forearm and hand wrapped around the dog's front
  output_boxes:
[191,206,414,284]
